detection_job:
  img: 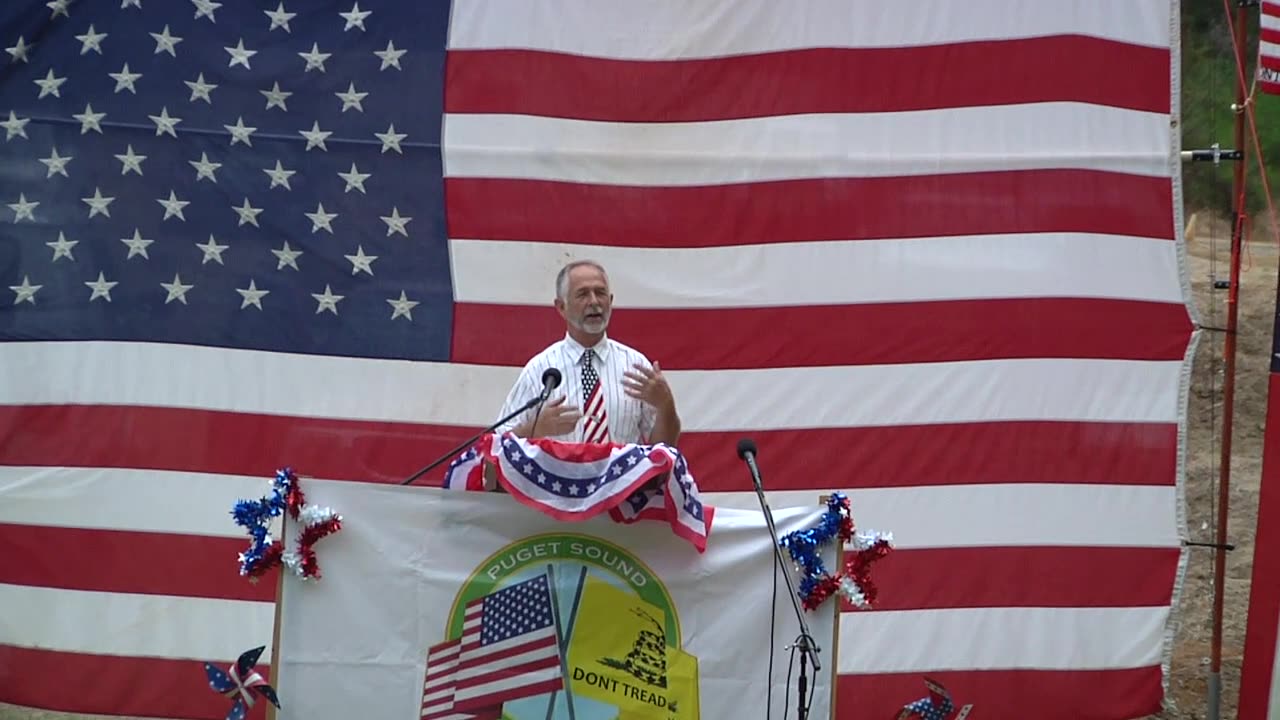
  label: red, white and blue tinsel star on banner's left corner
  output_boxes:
[232,468,342,582]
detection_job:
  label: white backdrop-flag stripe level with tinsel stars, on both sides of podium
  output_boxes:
[0,461,1178,550]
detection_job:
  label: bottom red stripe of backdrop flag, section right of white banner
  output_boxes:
[836,666,1164,720]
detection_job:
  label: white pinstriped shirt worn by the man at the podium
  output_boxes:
[497,334,658,443]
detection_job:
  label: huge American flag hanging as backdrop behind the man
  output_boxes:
[0,0,1196,720]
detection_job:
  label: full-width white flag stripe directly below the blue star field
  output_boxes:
[0,342,1181,427]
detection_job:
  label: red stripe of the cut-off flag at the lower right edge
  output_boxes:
[1238,368,1280,720]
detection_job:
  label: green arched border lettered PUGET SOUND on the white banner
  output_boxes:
[445,533,682,640]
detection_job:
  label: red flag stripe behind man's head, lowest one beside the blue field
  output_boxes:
[451,297,1192,370]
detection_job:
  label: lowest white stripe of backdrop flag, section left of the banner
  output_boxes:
[0,579,275,661]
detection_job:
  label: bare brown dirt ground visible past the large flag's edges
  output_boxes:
[0,210,1280,720]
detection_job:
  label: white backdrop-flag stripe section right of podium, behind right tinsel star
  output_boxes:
[701,484,1180,550]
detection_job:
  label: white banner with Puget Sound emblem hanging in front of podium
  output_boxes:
[274,480,838,720]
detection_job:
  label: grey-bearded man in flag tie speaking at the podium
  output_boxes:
[497,260,680,446]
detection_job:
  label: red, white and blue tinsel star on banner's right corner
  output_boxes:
[778,492,893,610]
